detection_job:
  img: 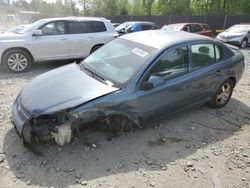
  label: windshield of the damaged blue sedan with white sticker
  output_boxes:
[82,39,157,87]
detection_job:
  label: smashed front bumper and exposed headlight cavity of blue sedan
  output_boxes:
[11,96,72,145]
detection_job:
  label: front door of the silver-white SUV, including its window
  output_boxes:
[32,21,69,61]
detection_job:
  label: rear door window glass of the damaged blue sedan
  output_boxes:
[191,44,215,70]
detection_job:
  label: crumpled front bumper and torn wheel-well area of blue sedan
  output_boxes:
[12,92,140,145]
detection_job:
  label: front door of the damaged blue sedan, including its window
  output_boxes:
[137,46,191,124]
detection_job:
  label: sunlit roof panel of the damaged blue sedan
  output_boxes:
[121,30,213,49]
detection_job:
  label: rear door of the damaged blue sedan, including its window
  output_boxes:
[190,42,223,102]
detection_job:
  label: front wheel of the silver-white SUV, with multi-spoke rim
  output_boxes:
[3,49,32,73]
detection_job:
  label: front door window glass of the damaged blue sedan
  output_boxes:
[149,47,188,79]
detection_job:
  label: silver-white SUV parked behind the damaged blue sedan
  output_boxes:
[0,17,118,73]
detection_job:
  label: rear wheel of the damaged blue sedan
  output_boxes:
[209,79,234,108]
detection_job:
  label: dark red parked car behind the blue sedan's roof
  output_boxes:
[161,23,213,37]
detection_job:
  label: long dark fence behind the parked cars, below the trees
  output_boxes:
[106,15,250,30]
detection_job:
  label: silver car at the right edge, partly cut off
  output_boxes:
[217,24,250,48]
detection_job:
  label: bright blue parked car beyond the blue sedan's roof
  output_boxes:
[115,21,158,35]
